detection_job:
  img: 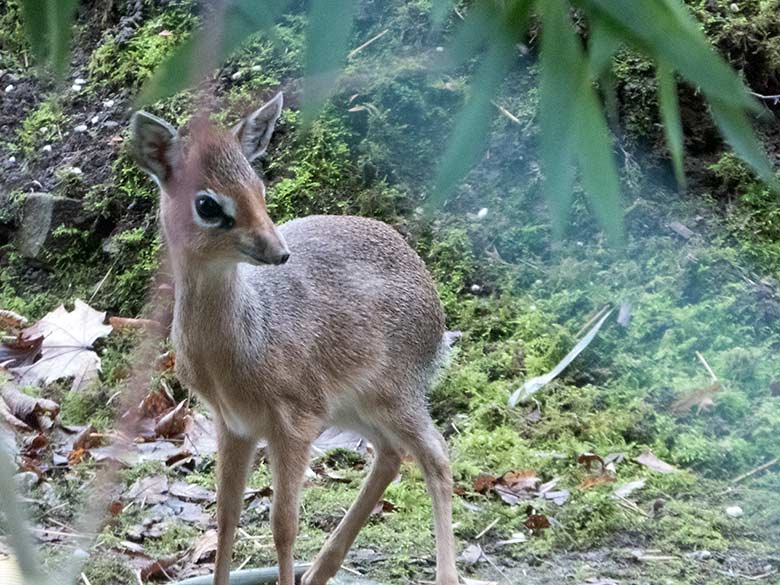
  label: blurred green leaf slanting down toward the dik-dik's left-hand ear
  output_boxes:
[135,0,289,107]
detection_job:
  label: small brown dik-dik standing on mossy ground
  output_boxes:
[131,94,458,585]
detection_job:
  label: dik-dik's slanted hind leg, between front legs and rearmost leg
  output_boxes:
[301,444,401,585]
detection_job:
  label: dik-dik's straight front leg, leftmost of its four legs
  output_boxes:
[214,424,256,585]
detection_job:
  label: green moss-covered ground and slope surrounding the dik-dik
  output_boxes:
[0,0,780,585]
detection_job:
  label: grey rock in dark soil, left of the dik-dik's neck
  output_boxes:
[15,193,86,258]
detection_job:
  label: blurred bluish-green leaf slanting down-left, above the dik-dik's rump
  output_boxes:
[428,36,515,207]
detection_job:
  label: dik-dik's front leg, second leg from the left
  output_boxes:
[268,433,316,585]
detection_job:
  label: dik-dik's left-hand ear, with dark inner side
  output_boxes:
[130,111,179,186]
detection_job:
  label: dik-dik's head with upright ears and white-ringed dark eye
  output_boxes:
[131,93,290,266]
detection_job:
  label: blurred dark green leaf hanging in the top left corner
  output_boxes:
[20,0,78,76]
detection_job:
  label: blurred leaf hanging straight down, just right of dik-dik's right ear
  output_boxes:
[301,0,356,126]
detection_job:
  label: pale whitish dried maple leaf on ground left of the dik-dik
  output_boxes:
[11,299,112,390]
